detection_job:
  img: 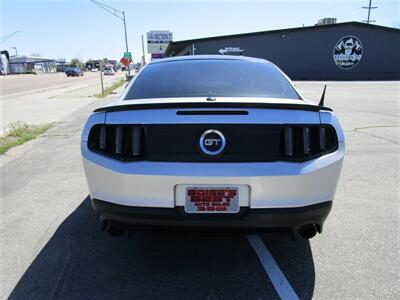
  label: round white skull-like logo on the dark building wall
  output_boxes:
[333,35,363,69]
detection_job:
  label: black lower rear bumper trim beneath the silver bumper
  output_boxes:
[92,199,332,232]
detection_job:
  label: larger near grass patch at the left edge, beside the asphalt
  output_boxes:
[0,122,53,155]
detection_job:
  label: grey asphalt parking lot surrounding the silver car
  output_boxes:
[0,82,400,299]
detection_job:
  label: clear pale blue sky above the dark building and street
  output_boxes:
[0,0,400,62]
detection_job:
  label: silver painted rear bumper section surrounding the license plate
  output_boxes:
[82,143,344,209]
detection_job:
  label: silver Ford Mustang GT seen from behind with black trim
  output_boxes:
[81,56,345,238]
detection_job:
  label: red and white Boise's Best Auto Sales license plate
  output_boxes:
[185,187,240,214]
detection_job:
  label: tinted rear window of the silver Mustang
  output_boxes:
[125,59,301,100]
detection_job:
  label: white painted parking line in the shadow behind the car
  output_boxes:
[247,235,299,300]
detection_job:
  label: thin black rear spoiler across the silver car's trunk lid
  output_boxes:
[93,102,332,112]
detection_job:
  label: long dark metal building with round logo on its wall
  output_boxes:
[165,22,400,80]
